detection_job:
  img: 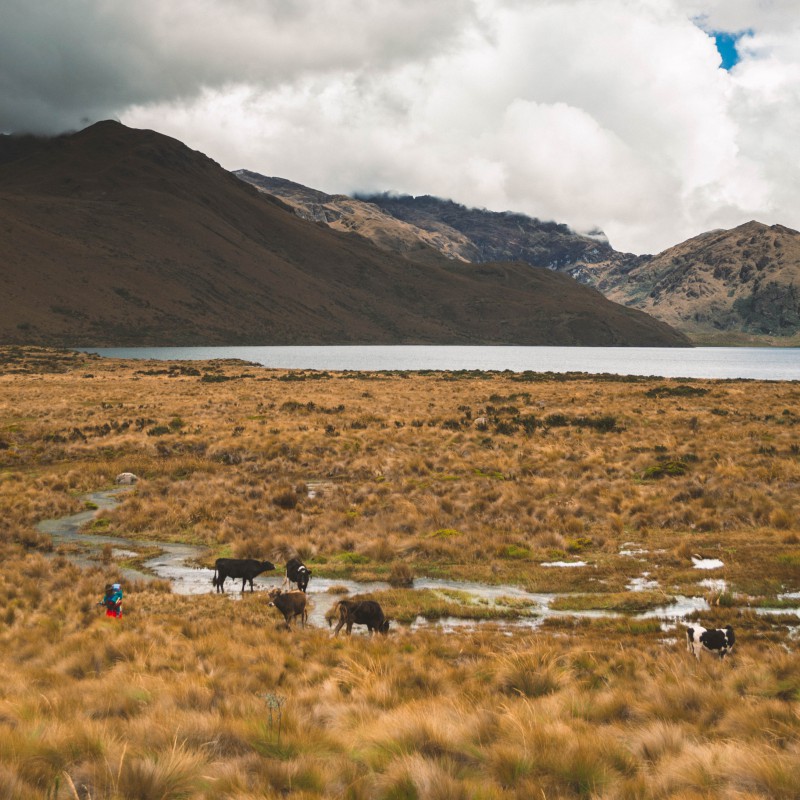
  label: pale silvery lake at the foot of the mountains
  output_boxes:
[79,345,800,381]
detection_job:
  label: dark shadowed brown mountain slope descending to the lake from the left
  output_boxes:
[0,122,686,346]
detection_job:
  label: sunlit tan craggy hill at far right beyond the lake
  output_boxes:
[598,222,800,340]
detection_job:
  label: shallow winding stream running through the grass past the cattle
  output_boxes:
[36,487,792,630]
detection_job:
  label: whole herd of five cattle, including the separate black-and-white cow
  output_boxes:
[211,558,736,660]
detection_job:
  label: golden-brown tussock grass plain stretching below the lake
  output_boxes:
[0,348,800,800]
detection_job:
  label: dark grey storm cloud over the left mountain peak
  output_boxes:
[0,0,471,133]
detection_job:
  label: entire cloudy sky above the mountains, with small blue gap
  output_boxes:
[0,0,800,253]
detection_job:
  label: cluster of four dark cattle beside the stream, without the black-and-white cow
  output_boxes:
[211,558,389,636]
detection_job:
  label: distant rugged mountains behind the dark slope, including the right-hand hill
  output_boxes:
[235,170,800,344]
